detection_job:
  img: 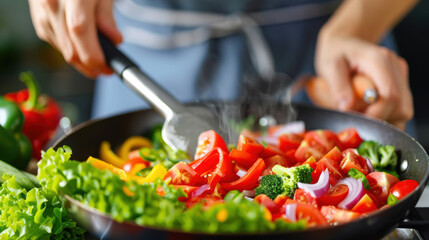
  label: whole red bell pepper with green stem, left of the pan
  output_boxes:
[4,72,61,160]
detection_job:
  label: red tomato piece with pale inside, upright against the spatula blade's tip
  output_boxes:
[194,130,229,159]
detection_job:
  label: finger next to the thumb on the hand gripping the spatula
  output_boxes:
[66,0,105,75]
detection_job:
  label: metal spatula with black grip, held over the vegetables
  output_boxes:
[98,32,228,157]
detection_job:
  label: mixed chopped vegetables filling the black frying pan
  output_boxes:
[38,124,418,233]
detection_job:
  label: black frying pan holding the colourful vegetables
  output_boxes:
[55,104,429,240]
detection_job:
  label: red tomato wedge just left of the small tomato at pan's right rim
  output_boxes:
[366,172,399,207]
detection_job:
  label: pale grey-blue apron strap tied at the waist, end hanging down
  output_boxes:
[115,0,341,81]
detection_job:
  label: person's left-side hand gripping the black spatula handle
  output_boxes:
[28,0,122,78]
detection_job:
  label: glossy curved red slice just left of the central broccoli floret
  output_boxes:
[222,158,265,191]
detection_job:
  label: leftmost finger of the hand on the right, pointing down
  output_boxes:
[319,58,355,111]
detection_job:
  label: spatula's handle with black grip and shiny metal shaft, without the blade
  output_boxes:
[98,31,183,119]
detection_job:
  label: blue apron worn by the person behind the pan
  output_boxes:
[92,0,412,135]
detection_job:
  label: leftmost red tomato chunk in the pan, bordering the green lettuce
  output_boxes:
[164,162,204,186]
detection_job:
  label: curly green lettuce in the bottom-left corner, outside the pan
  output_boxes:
[0,174,84,239]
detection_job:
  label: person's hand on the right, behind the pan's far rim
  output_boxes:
[315,31,414,129]
